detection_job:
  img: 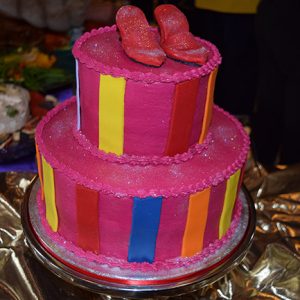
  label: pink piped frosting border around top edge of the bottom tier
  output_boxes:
[36,97,250,197]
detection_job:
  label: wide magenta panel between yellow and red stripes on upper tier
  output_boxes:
[124,80,175,155]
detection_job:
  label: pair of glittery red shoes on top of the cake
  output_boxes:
[116,4,208,67]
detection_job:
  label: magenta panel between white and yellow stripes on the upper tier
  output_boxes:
[79,63,100,147]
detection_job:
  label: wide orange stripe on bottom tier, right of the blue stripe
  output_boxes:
[181,188,210,256]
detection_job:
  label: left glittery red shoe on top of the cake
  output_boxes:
[116,5,166,67]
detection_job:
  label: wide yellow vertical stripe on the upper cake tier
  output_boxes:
[99,75,126,155]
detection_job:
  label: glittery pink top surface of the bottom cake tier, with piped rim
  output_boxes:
[36,98,249,197]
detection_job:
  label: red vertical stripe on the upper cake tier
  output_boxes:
[165,78,199,156]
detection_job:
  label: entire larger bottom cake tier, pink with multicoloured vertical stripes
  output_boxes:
[36,99,249,268]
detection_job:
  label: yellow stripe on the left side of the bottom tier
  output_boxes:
[42,156,58,231]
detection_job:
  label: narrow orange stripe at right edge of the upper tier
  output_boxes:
[199,68,218,144]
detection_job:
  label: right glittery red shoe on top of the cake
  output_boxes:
[154,4,209,64]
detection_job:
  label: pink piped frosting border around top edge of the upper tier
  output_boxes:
[72,25,222,83]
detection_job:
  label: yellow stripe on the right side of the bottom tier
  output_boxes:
[219,170,241,238]
